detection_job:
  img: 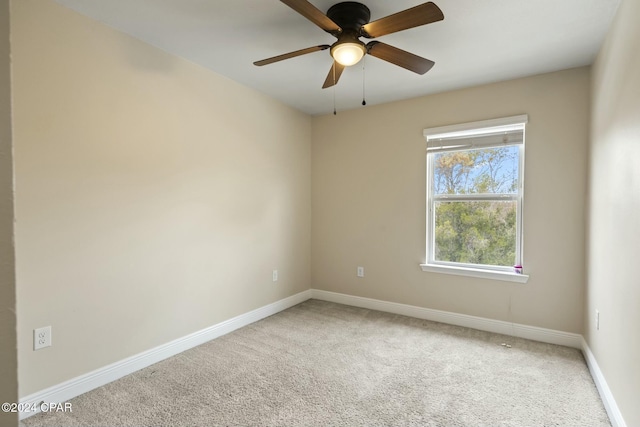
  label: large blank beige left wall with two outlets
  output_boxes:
[12,0,311,396]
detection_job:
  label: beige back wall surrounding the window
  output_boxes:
[311,68,590,333]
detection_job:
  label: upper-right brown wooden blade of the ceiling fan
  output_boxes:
[362,2,444,38]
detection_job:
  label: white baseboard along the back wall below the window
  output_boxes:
[311,289,582,349]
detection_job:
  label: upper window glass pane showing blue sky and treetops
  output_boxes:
[433,145,519,195]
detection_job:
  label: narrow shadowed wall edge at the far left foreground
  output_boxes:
[0,0,18,426]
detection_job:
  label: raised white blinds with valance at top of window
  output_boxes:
[424,115,528,153]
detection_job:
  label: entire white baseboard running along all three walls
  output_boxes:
[20,289,626,427]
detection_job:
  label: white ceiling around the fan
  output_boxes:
[56,0,620,115]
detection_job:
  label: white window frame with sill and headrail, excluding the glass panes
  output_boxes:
[420,114,529,283]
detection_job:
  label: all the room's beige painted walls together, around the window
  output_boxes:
[11,0,640,425]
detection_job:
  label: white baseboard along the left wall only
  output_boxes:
[20,290,311,419]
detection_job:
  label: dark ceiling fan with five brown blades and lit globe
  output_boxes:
[254,0,444,89]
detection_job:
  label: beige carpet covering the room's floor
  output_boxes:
[23,300,610,427]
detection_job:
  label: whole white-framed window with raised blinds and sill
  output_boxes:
[422,115,528,282]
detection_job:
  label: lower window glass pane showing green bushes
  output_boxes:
[434,200,517,267]
